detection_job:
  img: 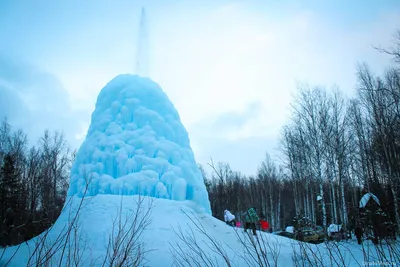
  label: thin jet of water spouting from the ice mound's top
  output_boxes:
[136,7,149,77]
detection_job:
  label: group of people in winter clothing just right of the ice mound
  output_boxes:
[224,207,272,235]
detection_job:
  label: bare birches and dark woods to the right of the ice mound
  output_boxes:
[203,31,400,237]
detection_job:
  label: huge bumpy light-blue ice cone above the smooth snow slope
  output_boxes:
[68,74,211,213]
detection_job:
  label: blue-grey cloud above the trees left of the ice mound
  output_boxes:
[0,54,86,147]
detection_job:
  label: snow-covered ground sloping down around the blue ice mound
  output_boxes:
[0,194,396,266]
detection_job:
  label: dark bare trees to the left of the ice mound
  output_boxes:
[0,118,74,246]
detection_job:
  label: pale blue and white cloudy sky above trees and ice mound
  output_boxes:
[0,0,400,174]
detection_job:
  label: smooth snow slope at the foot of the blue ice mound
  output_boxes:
[0,194,374,267]
